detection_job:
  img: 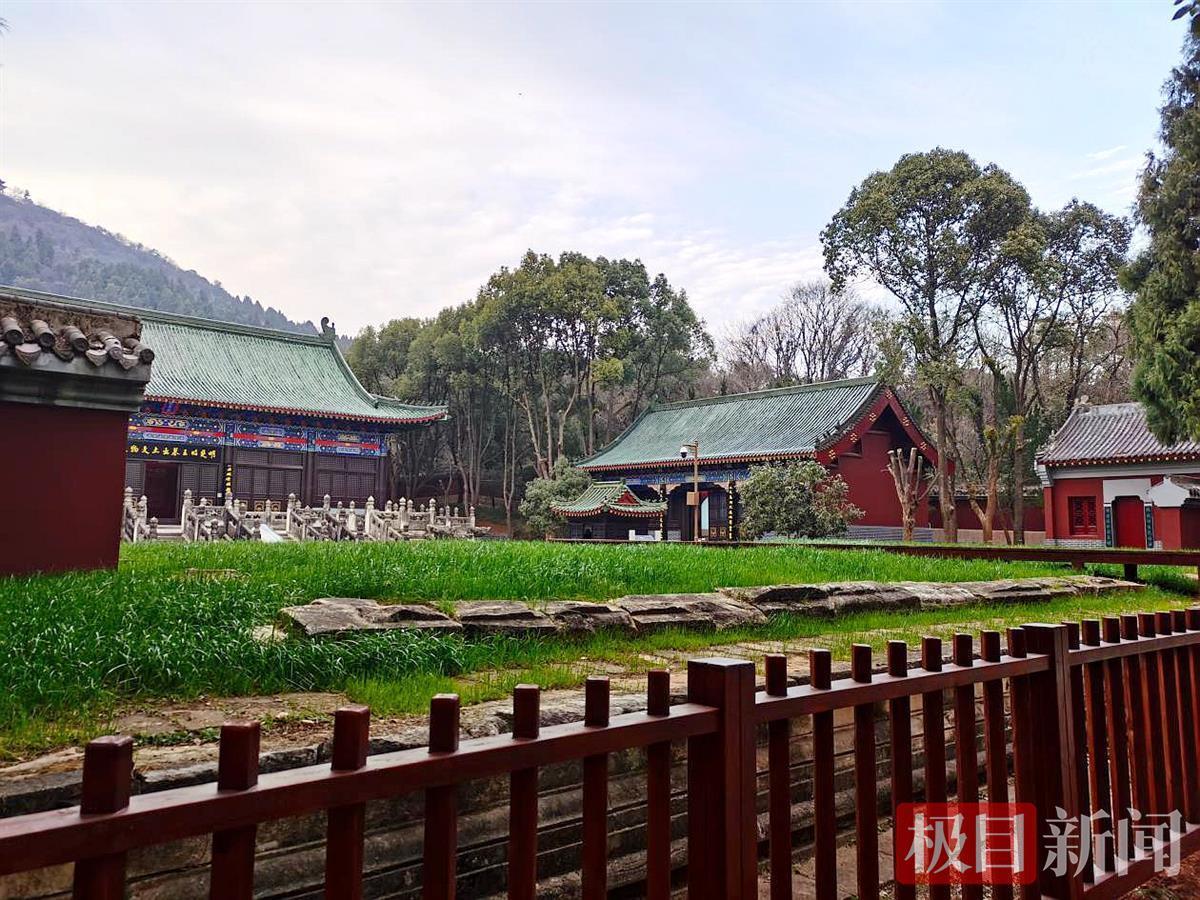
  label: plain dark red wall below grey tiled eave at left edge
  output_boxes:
[0,402,128,575]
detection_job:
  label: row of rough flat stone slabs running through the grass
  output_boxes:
[280,575,1141,637]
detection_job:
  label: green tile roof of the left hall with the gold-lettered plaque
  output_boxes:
[5,288,446,424]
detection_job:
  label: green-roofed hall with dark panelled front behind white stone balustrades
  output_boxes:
[0,288,446,523]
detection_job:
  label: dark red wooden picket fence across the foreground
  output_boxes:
[0,610,1200,900]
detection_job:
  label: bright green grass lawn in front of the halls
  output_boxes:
[0,541,1188,757]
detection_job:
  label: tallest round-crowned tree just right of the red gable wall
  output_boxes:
[821,148,1030,541]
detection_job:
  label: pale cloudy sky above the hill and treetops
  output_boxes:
[0,0,1183,332]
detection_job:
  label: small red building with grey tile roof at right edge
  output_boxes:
[1037,402,1200,550]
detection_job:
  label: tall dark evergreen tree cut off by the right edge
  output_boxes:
[1123,2,1200,443]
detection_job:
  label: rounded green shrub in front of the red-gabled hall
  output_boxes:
[740,460,863,539]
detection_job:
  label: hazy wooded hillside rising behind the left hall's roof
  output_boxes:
[0,190,317,332]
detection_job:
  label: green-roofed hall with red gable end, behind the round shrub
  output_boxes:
[563,378,937,540]
